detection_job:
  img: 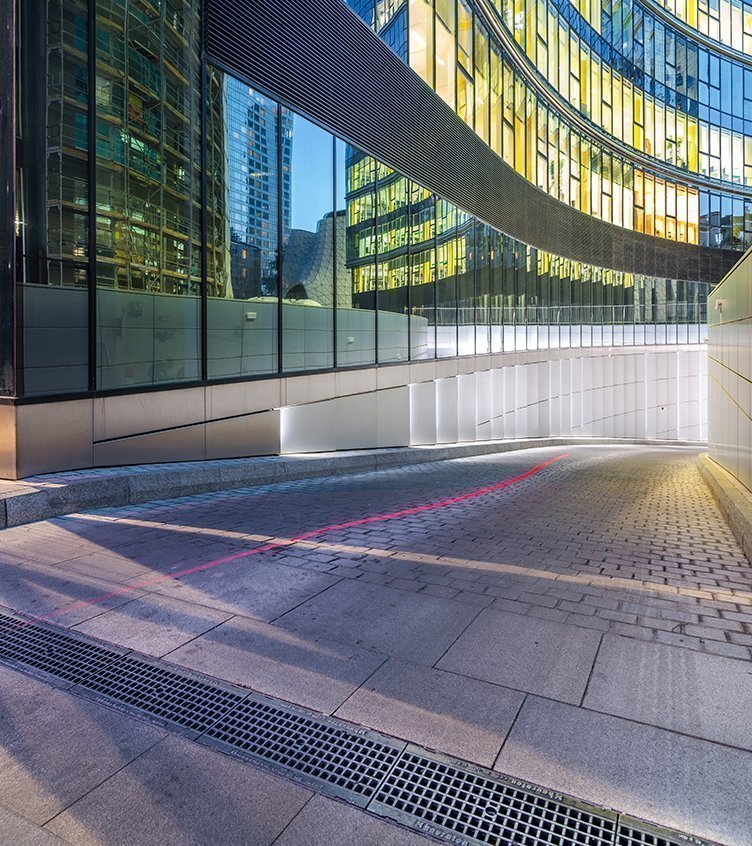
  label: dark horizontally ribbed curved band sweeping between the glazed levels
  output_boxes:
[205,0,738,282]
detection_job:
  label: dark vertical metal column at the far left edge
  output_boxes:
[0,0,16,396]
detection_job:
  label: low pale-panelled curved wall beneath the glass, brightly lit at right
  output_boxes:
[0,345,707,479]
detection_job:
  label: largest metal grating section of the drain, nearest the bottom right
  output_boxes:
[369,748,617,846]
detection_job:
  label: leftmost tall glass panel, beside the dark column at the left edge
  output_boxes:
[16,0,90,395]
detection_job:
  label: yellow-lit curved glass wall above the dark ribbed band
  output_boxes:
[382,0,752,250]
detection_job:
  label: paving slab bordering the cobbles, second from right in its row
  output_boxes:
[437,608,601,703]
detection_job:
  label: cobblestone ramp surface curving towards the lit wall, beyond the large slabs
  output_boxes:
[0,447,752,658]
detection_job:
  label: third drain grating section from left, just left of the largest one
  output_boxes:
[204,699,405,806]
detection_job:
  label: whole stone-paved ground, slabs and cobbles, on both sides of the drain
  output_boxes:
[0,445,752,846]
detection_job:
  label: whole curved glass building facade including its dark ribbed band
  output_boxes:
[0,0,740,475]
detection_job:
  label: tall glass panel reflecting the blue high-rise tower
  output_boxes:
[207,69,282,378]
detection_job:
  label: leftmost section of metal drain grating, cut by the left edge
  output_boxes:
[0,614,120,684]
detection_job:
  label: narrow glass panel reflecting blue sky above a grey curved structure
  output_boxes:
[282,109,334,371]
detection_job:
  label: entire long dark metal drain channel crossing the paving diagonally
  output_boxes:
[0,613,719,846]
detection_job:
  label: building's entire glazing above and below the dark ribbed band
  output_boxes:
[5,0,720,408]
